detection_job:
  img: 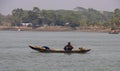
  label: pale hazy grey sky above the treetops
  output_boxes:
[0,0,120,15]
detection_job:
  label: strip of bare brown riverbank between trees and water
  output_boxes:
[0,26,110,32]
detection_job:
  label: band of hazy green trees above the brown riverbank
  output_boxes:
[0,7,120,28]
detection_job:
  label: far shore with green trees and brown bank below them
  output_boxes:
[0,7,120,31]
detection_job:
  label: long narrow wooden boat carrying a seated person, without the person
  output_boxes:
[29,45,91,53]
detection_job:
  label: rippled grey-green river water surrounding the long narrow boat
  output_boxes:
[0,31,120,71]
